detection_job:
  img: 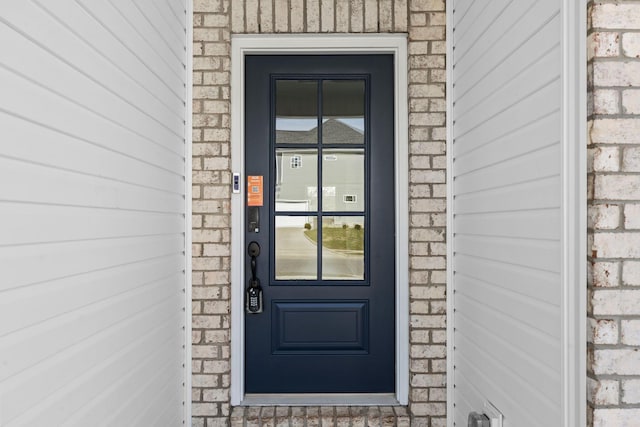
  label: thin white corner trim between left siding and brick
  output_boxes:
[183,0,193,426]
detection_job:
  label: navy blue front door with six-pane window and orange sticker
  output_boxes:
[244,55,395,393]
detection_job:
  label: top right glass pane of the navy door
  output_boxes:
[322,80,364,144]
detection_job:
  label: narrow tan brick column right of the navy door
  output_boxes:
[408,0,447,427]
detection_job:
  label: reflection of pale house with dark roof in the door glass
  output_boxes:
[276,119,365,226]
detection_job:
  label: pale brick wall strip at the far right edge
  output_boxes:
[587,1,640,427]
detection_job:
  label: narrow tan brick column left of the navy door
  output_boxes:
[192,0,231,427]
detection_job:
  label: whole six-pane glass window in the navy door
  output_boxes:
[271,79,366,282]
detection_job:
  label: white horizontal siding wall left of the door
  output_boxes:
[0,0,187,427]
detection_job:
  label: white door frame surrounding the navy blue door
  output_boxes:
[231,34,409,405]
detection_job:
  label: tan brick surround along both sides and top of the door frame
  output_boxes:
[193,0,446,427]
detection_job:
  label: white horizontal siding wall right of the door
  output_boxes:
[450,0,563,427]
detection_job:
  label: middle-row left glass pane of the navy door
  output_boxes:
[274,148,318,212]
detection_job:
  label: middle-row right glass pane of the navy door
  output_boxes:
[322,148,365,212]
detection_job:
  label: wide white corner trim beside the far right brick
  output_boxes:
[561,0,587,426]
